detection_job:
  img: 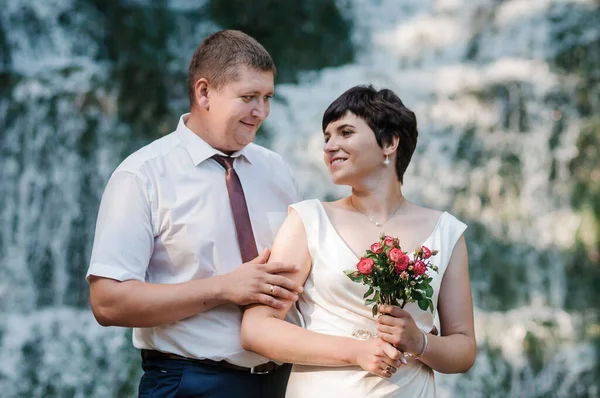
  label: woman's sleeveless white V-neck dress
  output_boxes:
[286,199,466,398]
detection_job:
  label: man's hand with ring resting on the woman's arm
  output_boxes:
[224,249,303,309]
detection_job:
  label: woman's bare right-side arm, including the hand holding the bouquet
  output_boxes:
[379,236,477,373]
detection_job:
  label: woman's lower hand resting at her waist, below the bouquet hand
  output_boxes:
[355,338,402,379]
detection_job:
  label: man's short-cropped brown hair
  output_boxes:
[187,30,277,107]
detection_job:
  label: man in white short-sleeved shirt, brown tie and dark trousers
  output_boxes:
[87,31,302,398]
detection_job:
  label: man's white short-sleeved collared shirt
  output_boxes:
[87,114,298,367]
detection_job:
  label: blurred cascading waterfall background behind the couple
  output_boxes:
[0,0,600,398]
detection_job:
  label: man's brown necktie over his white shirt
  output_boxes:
[212,155,258,263]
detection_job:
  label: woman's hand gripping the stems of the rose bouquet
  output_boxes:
[377,305,424,354]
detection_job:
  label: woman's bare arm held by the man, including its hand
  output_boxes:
[241,210,399,377]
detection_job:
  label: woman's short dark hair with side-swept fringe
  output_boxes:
[322,85,419,183]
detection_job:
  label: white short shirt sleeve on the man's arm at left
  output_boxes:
[86,171,154,281]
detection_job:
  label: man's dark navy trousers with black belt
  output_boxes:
[139,359,291,398]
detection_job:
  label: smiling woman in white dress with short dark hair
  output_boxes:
[242,86,476,398]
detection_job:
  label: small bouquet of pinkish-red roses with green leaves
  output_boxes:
[344,234,438,316]
